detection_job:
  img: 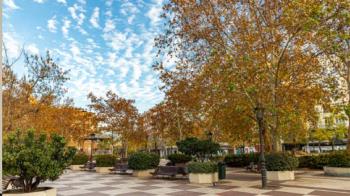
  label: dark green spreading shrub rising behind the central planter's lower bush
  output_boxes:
[176,137,220,159]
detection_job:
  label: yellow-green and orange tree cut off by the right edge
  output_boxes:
[313,0,350,152]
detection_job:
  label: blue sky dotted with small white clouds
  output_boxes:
[3,0,172,112]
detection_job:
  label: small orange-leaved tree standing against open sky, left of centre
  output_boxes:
[88,91,139,157]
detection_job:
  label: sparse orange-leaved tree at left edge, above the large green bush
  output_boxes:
[3,47,68,132]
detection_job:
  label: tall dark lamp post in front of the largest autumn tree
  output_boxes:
[255,106,267,189]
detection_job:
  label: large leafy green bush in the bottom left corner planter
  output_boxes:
[3,131,76,192]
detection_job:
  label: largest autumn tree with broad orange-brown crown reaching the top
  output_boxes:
[155,0,326,151]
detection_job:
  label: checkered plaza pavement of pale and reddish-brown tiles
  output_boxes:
[42,168,350,196]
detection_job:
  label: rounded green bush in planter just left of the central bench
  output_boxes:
[128,152,159,170]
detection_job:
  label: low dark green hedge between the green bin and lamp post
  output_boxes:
[224,153,259,167]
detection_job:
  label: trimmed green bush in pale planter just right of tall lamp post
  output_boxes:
[266,153,299,171]
